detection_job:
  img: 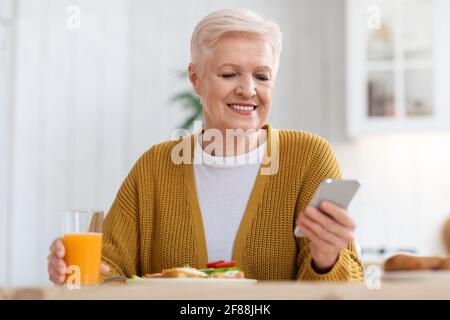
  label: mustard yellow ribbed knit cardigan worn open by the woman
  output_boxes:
[102,125,363,282]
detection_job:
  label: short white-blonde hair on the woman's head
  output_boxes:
[191,9,283,73]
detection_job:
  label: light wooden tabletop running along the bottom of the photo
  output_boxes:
[0,279,450,300]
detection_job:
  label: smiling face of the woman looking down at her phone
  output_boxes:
[189,33,275,132]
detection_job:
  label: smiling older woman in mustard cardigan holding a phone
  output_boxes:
[48,9,363,283]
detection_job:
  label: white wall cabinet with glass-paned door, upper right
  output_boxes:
[346,0,450,136]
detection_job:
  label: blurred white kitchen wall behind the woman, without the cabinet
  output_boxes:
[0,0,450,285]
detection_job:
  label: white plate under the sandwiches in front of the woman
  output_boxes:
[127,278,257,285]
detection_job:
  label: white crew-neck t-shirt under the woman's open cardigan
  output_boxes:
[194,136,266,262]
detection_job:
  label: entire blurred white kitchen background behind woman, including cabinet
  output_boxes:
[0,0,450,285]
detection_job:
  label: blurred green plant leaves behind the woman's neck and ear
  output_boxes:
[170,72,203,130]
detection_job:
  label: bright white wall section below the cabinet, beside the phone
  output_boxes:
[335,132,450,255]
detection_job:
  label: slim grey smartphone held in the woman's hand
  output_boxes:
[294,179,360,238]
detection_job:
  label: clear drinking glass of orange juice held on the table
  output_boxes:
[63,210,104,287]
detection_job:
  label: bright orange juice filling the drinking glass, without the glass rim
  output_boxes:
[63,232,102,285]
